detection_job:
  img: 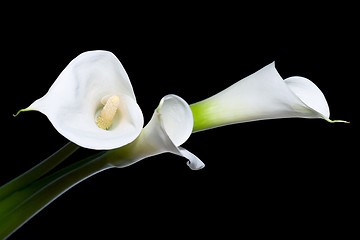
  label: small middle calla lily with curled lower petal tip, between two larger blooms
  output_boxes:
[106,95,205,170]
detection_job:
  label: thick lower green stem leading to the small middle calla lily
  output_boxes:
[0,152,112,239]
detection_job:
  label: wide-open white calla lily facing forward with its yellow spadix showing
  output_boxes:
[15,51,144,150]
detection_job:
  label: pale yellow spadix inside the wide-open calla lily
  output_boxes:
[96,95,120,130]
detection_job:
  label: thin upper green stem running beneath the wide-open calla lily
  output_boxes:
[0,142,79,200]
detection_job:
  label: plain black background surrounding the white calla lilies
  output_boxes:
[0,2,358,239]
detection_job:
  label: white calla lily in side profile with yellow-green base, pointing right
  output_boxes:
[191,62,345,131]
